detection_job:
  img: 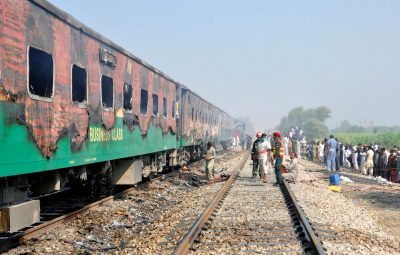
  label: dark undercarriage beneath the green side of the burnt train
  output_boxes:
[0,145,209,232]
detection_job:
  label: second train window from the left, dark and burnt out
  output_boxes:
[72,65,87,106]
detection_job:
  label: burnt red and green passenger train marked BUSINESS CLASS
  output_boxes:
[0,0,239,231]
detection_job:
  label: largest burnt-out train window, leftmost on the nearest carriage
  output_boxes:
[28,47,53,98]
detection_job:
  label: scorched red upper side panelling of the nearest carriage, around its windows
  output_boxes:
[0,0,176,158]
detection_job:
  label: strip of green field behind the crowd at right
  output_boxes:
[335,132,400,149]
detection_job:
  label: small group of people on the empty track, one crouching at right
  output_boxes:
[251,132,297,186]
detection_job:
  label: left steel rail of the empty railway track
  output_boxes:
[172,154,250,255]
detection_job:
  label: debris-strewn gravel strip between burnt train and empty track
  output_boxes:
[5,151,246,255]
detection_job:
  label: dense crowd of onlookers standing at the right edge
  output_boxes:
[305,136,400,182]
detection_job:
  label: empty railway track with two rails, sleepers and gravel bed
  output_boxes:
[173,155,325,255]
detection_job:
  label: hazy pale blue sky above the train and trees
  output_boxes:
[51,0,400,129]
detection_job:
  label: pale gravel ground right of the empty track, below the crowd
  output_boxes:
[290,161,400,254]
